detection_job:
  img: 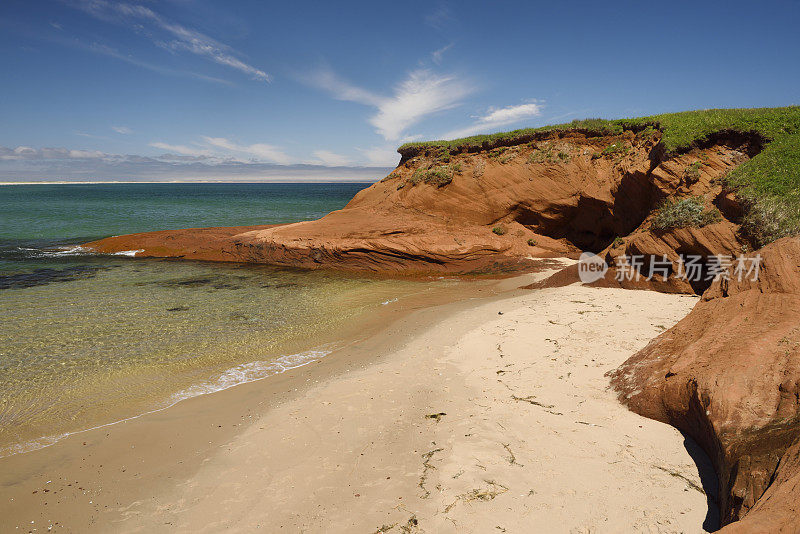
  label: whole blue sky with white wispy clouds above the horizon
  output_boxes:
[0,0,800,181]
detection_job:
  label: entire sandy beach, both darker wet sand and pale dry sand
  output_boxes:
[0,274,713,532]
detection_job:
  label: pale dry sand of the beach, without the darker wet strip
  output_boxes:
[111,286,707,533]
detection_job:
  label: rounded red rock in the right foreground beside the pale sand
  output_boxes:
[611,238,800,532]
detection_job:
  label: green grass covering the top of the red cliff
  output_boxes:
[398,106,800,245]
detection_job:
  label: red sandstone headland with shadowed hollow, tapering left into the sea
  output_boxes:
[86,132,746,278]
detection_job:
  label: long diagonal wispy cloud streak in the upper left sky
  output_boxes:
[70,0,270,82]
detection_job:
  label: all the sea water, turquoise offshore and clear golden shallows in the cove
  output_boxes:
[0,183,457,456]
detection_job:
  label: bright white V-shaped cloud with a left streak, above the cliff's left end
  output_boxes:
[306,69,473,141]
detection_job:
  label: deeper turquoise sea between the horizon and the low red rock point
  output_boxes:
[0,183,369,274]
